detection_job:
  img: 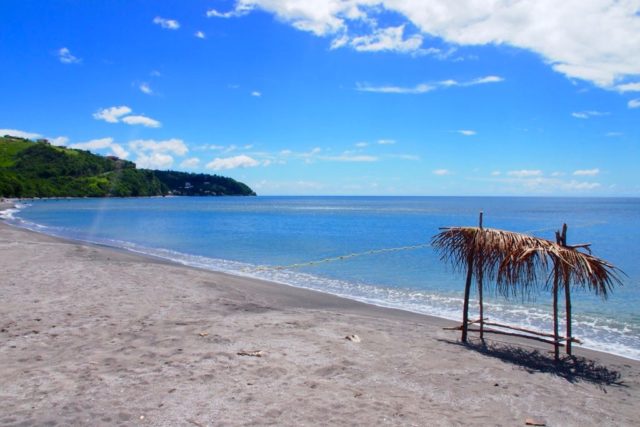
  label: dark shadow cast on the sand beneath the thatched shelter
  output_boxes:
[442,340,626,387]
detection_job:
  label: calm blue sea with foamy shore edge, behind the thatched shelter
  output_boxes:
[0,196,640,360]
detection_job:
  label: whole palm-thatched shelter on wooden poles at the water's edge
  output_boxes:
[432,213,622,360]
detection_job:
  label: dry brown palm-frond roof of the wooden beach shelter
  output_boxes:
[432,227,621,297]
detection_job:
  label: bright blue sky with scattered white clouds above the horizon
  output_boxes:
[0,0,640,196]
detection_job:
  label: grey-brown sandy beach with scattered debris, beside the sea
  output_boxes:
[0,206,640,426]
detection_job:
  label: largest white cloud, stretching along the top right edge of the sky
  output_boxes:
[216,0,640,89]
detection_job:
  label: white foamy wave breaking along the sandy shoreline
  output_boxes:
[3,205,640,360]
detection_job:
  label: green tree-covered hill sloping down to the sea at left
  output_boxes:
[0,136,255,197]
